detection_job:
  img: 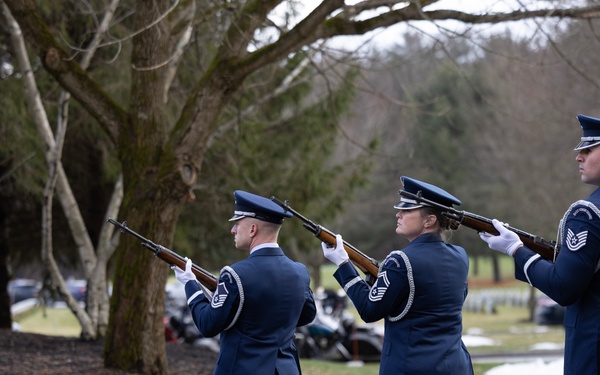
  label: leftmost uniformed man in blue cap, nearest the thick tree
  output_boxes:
[173,190,316,375]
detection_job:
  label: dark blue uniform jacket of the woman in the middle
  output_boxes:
[334,234,473,375]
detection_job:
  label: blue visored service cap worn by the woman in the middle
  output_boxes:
[394,176,462,210]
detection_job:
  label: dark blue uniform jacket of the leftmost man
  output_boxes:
[185,247,316,375]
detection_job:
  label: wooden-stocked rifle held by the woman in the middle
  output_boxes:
[271,197,379,285]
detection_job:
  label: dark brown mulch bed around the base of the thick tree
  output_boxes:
[0,329,217,375]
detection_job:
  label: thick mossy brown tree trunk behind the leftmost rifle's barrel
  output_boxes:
[104,0,176,374]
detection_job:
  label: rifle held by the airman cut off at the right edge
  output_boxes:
[399,190,560,262]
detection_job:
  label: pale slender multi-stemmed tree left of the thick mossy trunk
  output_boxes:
[2,0,122,339]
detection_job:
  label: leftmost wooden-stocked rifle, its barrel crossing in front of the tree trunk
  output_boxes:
[107,218,218,292]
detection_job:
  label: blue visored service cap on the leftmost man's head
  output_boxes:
[229,190,292,224]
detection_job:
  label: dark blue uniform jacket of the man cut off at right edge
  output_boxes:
[515,189,600,375]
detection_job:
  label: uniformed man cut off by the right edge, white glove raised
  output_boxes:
[480,115,600,375]
